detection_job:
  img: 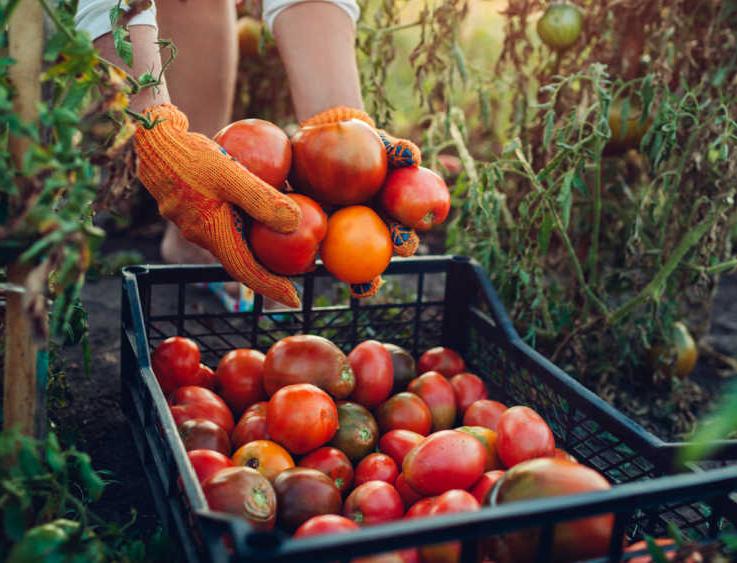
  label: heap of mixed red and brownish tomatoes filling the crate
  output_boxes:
[152,335,656,562]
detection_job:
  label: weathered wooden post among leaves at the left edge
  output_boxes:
[3,0,46,436]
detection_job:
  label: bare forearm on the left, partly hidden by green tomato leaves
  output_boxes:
[95,25,169,111]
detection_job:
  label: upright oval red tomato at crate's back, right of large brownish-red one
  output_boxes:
[348,340,394,409]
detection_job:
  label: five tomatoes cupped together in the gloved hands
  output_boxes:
[214,119,450,294]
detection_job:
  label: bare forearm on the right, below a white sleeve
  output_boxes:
[274,2,363,121]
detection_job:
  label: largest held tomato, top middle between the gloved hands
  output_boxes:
[290,119,387,207]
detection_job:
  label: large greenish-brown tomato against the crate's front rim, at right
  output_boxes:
[493,458,614,561]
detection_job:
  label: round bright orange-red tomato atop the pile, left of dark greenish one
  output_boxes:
[266,383,338,454]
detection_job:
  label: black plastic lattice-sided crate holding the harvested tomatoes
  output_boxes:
[121,256,737,561]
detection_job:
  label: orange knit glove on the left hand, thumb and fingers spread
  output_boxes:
[135,104,300,307]
